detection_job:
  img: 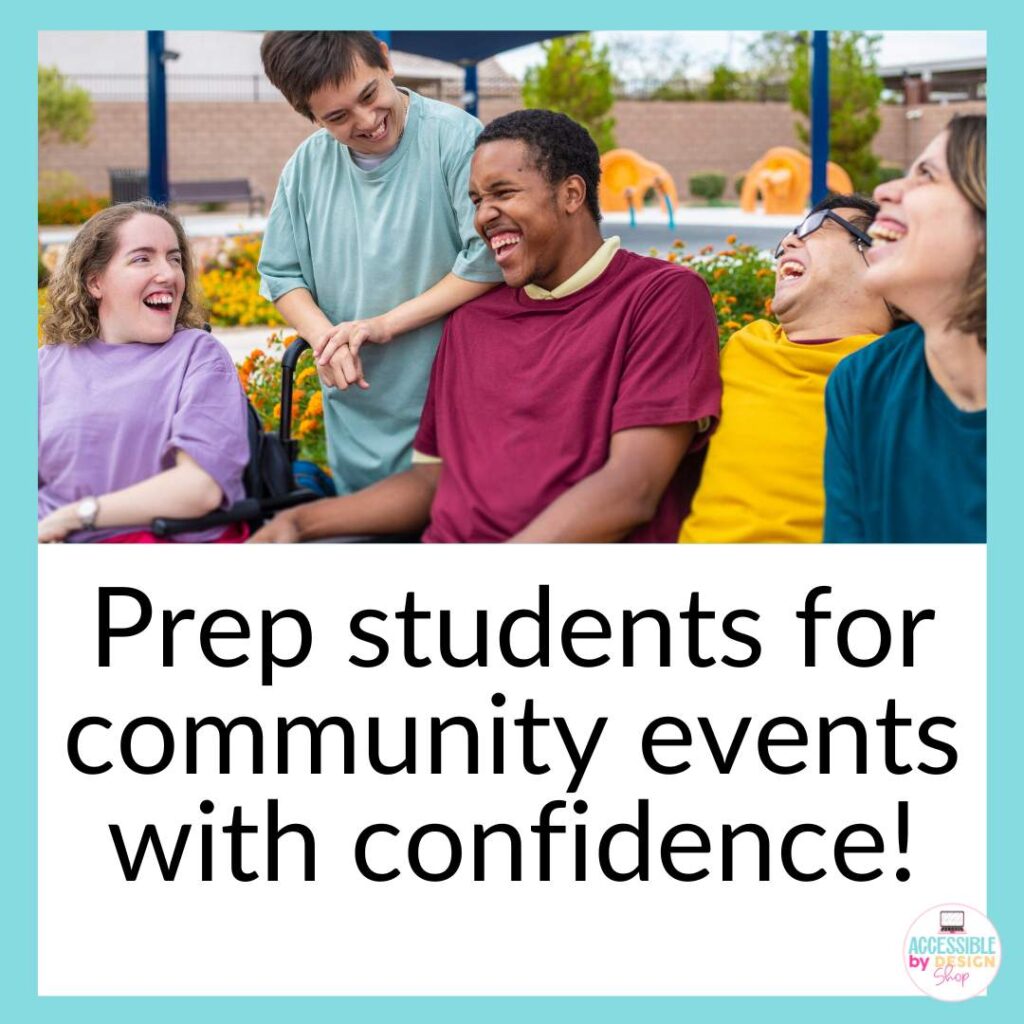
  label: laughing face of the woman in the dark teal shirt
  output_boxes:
[866,132,984,321]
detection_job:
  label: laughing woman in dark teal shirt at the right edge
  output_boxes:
[824,115,987,543]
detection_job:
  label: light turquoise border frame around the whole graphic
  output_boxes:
[8,0,1024,1024]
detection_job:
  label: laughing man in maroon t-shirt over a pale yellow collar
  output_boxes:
[254,111,721,542]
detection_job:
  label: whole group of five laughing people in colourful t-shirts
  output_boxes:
[38,32,987,544]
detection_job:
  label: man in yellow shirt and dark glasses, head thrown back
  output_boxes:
[679,195,893,544]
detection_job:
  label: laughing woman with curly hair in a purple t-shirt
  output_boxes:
[39,202,249,542]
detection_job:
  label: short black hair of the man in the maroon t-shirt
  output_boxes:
[476,110,601,223]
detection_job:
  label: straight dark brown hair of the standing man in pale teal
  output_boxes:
[259,32,388,121]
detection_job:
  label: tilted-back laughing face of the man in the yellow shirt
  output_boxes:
[772,207,877,333]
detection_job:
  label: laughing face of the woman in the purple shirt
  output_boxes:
[86,213,185,345]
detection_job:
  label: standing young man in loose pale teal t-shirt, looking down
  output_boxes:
[259,32,501,495]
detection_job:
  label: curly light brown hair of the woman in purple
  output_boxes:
[42,200,205,345]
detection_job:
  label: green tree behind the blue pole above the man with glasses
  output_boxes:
[790,32,883,193]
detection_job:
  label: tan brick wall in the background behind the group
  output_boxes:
[39,95,985,209]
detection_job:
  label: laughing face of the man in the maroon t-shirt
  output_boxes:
[469,139,586,290]
